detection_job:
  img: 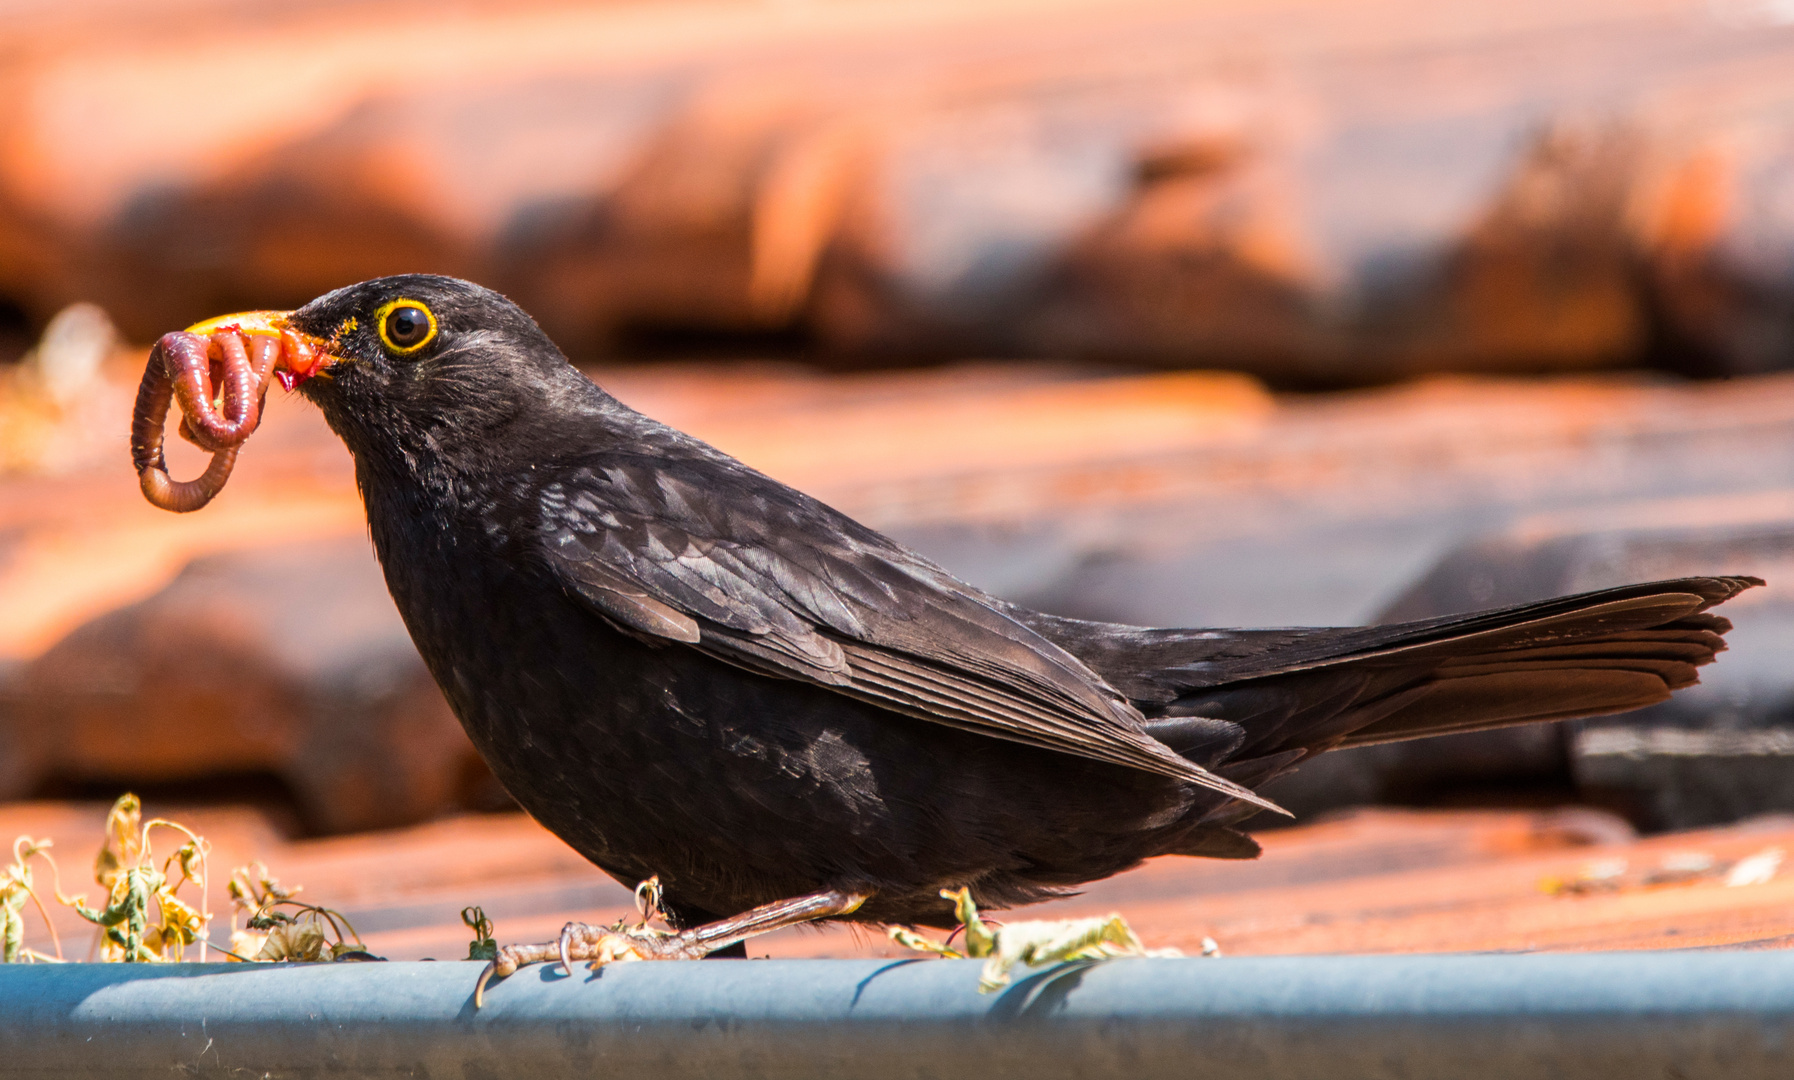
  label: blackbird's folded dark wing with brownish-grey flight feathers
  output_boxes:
[536,454,1270,807]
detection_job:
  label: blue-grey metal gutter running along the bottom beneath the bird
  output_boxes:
[0,953,1794,1080]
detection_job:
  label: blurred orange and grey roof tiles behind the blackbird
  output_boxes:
[0,0,1794,956]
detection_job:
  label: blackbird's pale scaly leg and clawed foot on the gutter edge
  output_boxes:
[474,890,870,1006]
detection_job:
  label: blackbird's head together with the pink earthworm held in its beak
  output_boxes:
[131,274,624,511]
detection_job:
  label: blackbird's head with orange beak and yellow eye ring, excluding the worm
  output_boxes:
[204,274,590,457]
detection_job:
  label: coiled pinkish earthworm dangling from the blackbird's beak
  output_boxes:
[131,330,282,513]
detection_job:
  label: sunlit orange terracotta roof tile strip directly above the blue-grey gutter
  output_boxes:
[14,804,1794,960]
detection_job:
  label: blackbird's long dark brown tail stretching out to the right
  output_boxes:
[1017,576,1762,786]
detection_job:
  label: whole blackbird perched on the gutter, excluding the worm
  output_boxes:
[161,274,1762,974]
